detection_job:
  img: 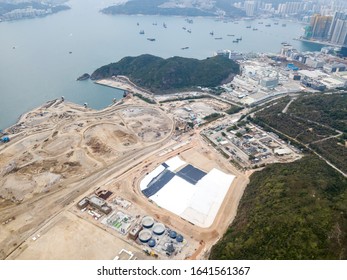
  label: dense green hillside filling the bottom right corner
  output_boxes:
[210,156,347,259]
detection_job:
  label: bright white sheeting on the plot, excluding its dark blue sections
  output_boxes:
[140,156,235,228]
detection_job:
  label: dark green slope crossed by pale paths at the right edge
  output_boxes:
[253,92,347,173]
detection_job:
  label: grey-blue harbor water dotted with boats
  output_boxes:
[0,0,318,129]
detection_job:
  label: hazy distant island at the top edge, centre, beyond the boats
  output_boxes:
[102,0,245,17]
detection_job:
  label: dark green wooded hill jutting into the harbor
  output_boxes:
[91,54,240,94]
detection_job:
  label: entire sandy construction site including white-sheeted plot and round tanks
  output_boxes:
[0,75,302,260]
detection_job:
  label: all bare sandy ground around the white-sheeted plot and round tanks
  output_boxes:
[0,92,249,259]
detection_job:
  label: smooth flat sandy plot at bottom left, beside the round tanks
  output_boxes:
[8,212,148,260]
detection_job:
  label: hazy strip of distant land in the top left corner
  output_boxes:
[0,0,70,22]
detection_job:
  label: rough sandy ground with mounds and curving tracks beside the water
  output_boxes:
[0,97,173,259]
